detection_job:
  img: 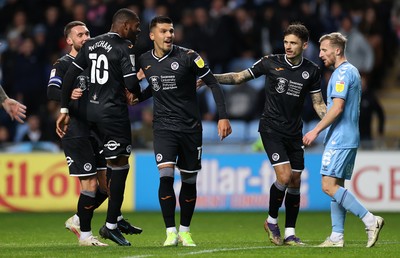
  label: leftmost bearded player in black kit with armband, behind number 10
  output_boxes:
[47,21,142,246]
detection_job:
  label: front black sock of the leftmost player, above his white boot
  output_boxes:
[78,191,96,232]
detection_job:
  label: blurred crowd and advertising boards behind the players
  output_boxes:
[0,0,400,212]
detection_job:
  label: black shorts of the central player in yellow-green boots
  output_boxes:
[154,130,203,173]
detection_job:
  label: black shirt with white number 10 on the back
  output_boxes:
[75,32,136,121]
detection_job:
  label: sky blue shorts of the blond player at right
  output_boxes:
[321,148,357,180]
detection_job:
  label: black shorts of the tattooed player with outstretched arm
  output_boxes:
[260,130,304,172]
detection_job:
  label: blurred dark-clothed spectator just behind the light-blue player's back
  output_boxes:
[359,76,385,149]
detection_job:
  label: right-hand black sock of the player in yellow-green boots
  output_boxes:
[179,182,197,227]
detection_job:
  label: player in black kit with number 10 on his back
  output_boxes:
[56,8,140,246]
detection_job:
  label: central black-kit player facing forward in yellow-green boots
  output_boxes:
[139,16,232,246]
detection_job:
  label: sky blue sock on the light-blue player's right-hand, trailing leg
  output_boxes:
[333,187,368,219]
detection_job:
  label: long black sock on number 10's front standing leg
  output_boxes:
[106,164,129,224]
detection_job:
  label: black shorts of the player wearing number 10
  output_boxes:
[93,119,132,159]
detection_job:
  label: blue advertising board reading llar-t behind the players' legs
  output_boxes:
[134,153,330,211]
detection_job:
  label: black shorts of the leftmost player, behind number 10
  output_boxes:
[61,137,97,177]
